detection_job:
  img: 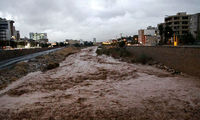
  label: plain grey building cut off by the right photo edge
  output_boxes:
[189,13,200,44]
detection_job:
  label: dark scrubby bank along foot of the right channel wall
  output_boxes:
[96,46,182,75]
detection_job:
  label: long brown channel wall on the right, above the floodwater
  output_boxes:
[127,46,200,77]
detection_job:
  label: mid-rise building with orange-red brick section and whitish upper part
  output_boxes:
[138,26,159,46]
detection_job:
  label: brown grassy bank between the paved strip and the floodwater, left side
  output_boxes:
[0,47,80,89]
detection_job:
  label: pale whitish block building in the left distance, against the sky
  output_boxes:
[29,32,48,43]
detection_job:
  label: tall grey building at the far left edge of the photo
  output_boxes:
[0,18,20,41]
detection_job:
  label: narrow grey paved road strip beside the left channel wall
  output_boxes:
[0,48,62,69]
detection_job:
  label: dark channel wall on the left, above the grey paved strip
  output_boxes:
[0,48,52,61]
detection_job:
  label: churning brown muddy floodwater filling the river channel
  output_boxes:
[0,47,200,120]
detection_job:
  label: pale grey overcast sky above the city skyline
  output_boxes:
[0,0,200,41]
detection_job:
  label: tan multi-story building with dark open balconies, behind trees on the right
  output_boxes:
[165,12,191,35]
